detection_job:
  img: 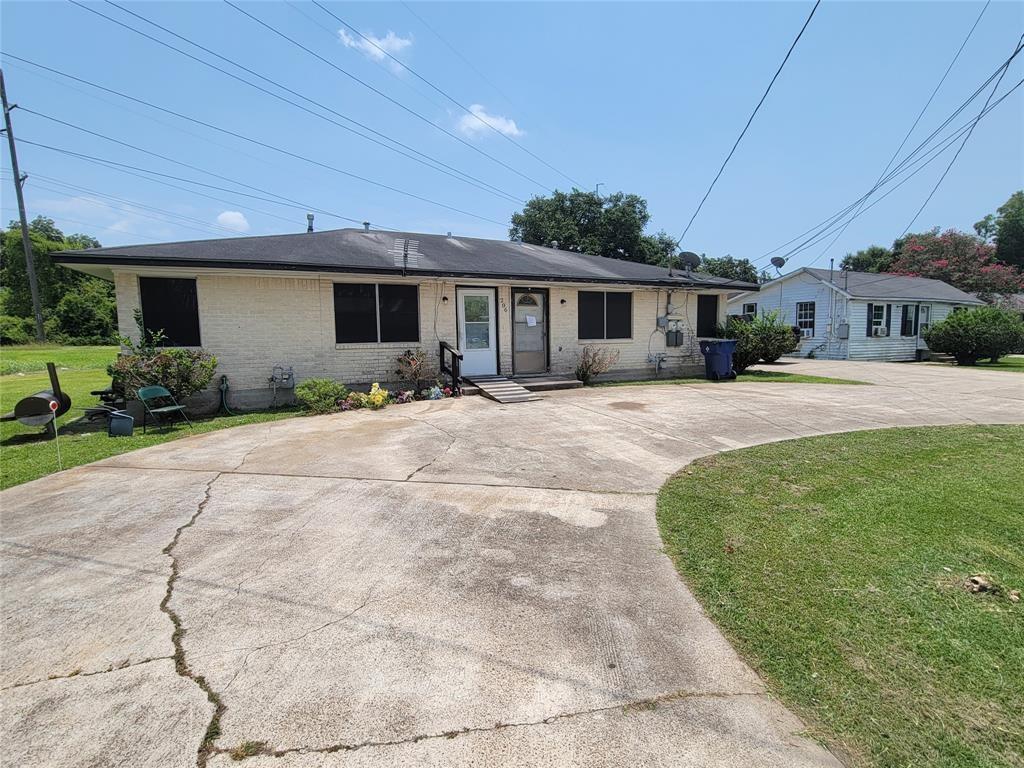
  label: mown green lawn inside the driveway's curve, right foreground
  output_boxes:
[657,426,1024,768]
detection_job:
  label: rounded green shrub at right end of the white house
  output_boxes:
[925,306,1024,366]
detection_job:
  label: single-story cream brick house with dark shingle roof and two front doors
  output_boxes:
[54,228,757,406]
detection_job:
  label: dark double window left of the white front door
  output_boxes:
[334,283,420,344]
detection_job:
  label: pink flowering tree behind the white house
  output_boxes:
[888,228,1024,299]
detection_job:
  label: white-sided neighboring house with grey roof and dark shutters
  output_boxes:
[729,267,984,360]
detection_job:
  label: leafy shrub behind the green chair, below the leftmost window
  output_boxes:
[106,347,217,400]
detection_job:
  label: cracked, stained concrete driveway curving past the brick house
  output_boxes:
[0,361,1024,768]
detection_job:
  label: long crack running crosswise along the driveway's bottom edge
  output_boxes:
[213,691,765,760]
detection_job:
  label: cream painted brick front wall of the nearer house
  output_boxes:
[115,269,726,401]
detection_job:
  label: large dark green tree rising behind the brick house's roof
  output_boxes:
[509,188,676,264]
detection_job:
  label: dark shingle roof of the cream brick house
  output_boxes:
[53,229,757,290]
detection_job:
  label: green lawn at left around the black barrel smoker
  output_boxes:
[0,345,297,488]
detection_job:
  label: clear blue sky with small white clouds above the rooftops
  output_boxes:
[2,0,1024,274]
